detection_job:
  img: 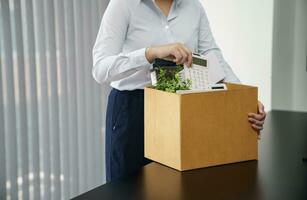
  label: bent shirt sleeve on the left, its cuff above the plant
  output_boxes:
[92,0,151,83]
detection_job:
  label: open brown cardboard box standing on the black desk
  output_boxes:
[145,84,258,171]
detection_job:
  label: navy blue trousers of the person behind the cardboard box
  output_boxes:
[105,89,150,182]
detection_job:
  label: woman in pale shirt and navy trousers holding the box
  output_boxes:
[92,0,265,182]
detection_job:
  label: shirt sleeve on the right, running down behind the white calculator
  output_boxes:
[198,4,240,83]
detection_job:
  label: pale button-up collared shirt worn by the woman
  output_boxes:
[92,0,239,90]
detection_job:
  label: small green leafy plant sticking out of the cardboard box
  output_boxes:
[154,66,191,93]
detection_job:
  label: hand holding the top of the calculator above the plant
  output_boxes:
[145,43,192,67]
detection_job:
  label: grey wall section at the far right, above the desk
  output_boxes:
[272,0,307,112]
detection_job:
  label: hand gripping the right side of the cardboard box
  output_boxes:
[248,101,266,139]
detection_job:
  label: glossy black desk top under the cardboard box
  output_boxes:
[75,111,307,200]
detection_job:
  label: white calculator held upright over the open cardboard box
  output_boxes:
[184,53,210,90]
